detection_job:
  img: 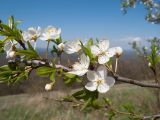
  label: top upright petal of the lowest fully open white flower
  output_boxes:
[97,65,107,80]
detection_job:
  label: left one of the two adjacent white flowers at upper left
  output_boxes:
[22,26,41,42]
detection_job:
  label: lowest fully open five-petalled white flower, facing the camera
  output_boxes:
[85,65,115,93]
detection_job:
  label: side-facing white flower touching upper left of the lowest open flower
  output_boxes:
[68,54,90,76]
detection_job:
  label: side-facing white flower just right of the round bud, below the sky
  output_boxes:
[64,40,81,54]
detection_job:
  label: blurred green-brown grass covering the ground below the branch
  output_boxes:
[0,84,158,120]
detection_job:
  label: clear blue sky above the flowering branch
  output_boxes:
[0,0,160,49]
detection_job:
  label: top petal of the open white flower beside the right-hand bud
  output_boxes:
[98,40,109,52]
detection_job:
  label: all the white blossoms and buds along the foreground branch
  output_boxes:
[4,26,123,93]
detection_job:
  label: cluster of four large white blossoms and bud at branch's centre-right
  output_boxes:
[64,40,123,93]
